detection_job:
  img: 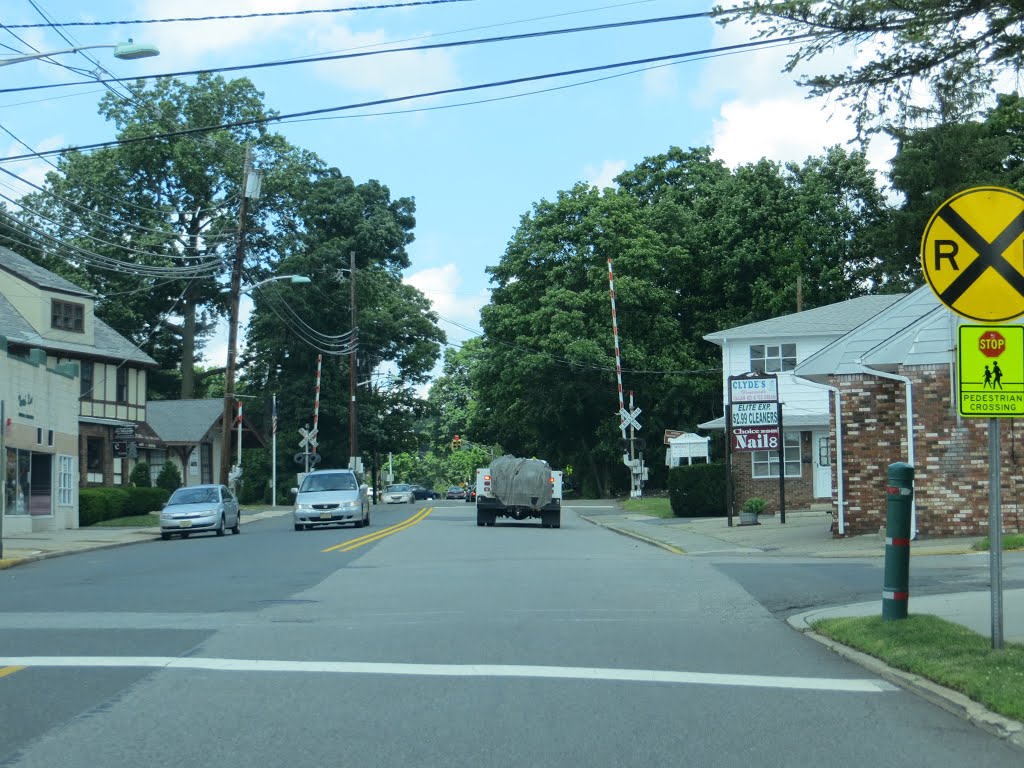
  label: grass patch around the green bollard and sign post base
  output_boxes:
[811,614,1024,722]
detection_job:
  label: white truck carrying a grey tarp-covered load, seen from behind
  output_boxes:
[476,456,562,528]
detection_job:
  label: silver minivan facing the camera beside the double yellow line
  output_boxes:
[292,469,370,530]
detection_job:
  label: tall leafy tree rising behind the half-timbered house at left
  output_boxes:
[14,75,316,397]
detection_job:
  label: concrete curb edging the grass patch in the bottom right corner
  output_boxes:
[786,613,1024,750]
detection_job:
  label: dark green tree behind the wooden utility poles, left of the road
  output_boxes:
[240,168,444,476]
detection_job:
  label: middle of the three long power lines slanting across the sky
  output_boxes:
[0,11,711,93]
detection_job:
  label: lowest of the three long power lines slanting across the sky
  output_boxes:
[0,34,812,162]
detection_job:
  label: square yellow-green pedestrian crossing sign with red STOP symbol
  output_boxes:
[956,325,1024,418]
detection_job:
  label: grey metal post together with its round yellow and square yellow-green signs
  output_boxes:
[921,186,1024,650]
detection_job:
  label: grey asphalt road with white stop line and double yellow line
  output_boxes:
[0,501,1021,768]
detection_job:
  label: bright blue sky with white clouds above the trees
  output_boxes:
[0,0,891,380]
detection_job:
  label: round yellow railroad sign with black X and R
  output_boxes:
[921,186,1024,323]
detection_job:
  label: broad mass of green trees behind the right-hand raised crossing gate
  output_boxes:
[469,142,901,494]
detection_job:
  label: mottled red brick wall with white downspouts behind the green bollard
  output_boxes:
[831,366,1024,538]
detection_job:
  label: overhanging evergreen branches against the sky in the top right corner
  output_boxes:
[715,0,1024,131]
